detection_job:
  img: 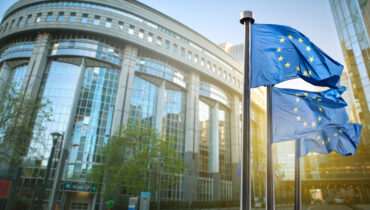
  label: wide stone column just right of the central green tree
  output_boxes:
[183,72,199,201]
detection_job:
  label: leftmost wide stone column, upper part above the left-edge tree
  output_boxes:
[22,34,50,99]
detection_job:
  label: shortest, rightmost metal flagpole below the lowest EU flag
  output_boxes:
[294,139,301,210]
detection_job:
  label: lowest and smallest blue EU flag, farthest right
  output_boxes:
[298,123,362,157]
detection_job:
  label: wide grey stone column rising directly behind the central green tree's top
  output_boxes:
[111,45,138,135]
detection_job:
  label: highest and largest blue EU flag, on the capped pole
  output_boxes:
[251,24,343,88]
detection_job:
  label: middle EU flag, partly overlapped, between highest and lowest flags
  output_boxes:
[271,87,348,143]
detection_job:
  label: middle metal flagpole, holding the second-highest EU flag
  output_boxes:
[266,85,275,210]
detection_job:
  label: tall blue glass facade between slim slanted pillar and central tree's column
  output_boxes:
[66,67,119,180]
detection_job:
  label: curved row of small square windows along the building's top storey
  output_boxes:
[0,12,243,88]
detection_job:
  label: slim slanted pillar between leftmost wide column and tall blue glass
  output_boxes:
[48,58,86,209]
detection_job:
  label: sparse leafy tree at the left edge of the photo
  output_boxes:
[0,84,52,165]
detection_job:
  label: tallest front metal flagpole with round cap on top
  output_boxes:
[240,11,254,210]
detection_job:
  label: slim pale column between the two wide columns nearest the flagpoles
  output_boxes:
[208,102,220,201]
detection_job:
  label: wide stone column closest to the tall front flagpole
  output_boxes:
[230,95,241,200]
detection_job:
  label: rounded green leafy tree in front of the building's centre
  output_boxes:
[90,123,184,199]
